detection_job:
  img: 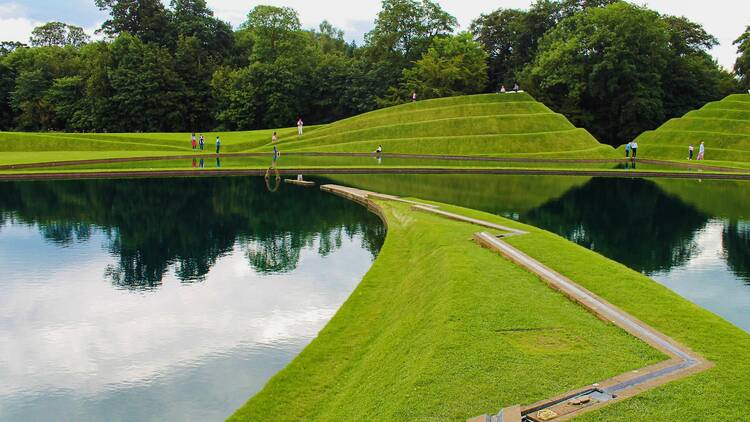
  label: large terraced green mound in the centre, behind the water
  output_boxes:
[254,93,613,158]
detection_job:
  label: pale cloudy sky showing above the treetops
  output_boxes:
[0,0,750,69]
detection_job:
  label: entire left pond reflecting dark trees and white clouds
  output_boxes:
[0,178,385,421]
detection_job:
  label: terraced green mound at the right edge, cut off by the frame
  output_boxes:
[632,94,750,165]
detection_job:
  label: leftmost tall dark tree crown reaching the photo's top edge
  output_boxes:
[94,0,173,45]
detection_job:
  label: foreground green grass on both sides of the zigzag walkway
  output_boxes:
[230,196,750,421]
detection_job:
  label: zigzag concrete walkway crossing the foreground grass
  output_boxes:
[321,185,713,422]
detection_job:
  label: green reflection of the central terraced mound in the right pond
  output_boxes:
[330,174,590,214]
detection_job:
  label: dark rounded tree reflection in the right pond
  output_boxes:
[522,179,708,273]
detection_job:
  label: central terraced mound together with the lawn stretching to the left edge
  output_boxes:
[0,93,614,164]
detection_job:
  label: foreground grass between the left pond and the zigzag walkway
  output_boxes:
[231,199,664,421]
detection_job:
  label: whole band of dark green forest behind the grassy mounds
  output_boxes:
[0,0,750,145]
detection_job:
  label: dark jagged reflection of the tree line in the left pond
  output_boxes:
[0,178,385,288]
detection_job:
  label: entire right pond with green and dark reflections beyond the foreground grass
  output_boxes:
[334,175,750,332]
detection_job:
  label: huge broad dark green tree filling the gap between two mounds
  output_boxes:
[521,2,726,145]
